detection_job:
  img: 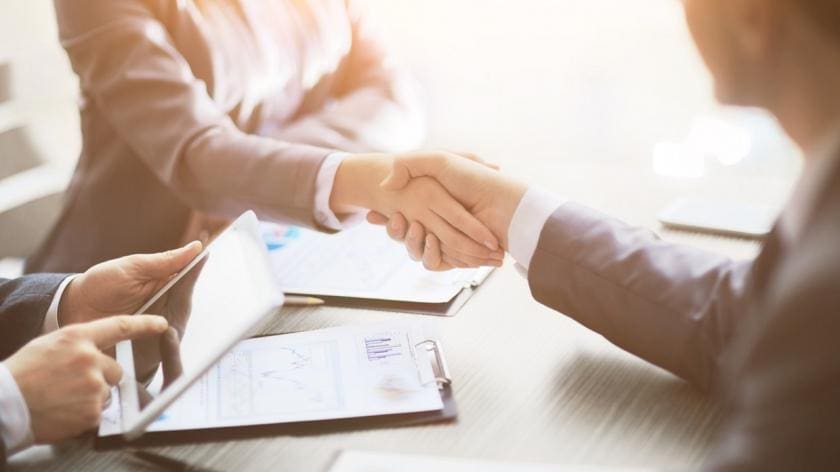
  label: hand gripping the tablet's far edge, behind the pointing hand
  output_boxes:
[58,242,202,326]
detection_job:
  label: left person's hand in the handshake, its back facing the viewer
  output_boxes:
[330,152,504,266]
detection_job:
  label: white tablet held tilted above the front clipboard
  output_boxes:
[116,212,283,440]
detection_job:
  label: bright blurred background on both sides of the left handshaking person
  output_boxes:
[0,0,800,274]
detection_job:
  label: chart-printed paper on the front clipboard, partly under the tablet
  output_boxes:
[99,321,443,436]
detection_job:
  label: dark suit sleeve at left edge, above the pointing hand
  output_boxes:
[0,274,67,359]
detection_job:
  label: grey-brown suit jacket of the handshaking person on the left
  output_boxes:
[26,0,422,272]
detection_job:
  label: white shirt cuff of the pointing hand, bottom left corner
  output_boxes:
[0,363,33,455]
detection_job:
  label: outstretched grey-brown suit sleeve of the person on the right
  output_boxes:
[528,203,752,390]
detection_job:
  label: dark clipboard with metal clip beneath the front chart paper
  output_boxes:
[94,334,458,451]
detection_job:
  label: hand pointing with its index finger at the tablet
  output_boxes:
[5,315,168,443]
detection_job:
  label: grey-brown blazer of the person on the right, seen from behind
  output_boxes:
[529,154,840,471]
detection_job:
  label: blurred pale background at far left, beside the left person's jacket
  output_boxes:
[0,0,81,277]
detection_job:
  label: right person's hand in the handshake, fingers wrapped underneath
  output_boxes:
[368,154,527,270]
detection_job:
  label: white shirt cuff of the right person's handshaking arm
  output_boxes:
[508,187,568,276]
